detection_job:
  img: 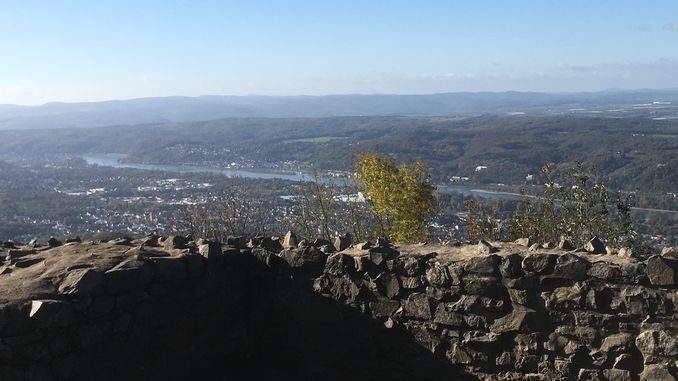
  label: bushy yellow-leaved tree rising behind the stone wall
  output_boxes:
[356,153,436,242]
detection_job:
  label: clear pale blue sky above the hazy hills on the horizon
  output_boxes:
[0,0,678,104]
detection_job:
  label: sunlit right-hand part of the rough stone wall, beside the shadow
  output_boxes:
[314,245,678,380]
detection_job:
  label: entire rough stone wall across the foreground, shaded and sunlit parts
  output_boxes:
[0,237,678,381]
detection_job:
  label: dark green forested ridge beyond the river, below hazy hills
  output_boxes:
[0,115,678,200]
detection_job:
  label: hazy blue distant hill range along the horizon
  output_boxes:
[0,89,678,130]
